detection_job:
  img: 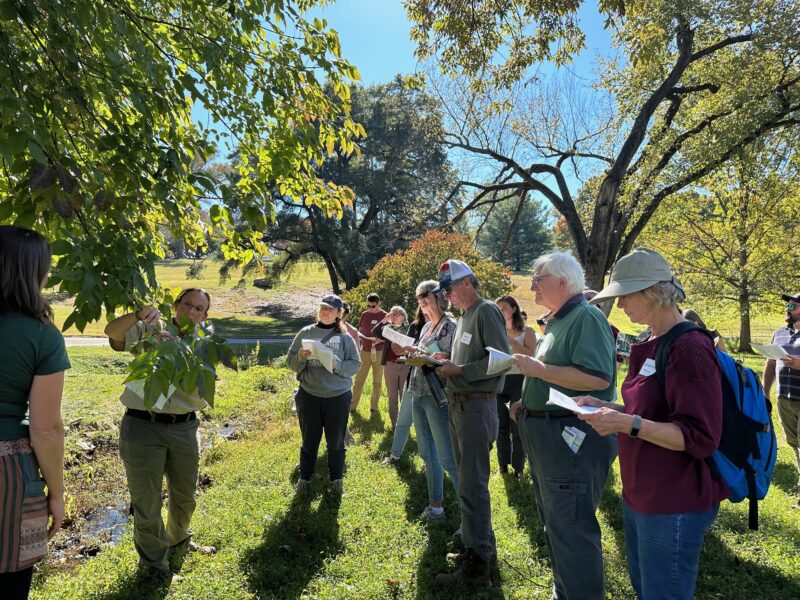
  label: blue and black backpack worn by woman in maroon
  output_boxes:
[656,322,777,529]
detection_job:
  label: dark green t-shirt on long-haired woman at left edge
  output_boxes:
[0,313,70,440]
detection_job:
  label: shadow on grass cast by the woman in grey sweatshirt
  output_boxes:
[241,478,344,599]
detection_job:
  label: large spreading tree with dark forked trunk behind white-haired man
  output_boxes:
[406,0,800,289]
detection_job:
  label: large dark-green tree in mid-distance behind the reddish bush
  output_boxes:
[255,77,455,293]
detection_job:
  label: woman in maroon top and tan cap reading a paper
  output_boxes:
[575,248,728,600]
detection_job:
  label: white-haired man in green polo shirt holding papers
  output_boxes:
[511,252,617,600]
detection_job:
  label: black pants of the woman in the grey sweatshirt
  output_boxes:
[297,387,352,481]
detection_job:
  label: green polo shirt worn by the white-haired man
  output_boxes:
[522,294,617,410]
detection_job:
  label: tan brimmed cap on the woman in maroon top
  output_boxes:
[589,248,686,304]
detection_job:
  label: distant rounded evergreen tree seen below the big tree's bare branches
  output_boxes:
[477,199,552,271]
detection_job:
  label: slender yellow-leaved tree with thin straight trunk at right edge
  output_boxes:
[642,148,800,352]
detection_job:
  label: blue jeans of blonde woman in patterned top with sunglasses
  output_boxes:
[411,396,459,502]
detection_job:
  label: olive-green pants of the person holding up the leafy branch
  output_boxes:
[119,415,200,570]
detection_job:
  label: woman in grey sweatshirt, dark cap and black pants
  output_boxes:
[286,294,361,493]
